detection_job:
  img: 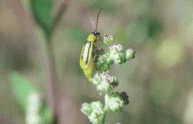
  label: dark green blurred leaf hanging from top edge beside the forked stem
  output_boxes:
[31,0,52,34]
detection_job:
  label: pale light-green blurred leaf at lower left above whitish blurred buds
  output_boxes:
[10,72,35,111]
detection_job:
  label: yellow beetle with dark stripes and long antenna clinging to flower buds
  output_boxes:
[80,8,103,82]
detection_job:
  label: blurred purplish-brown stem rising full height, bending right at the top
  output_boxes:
[47,2,67,123]
